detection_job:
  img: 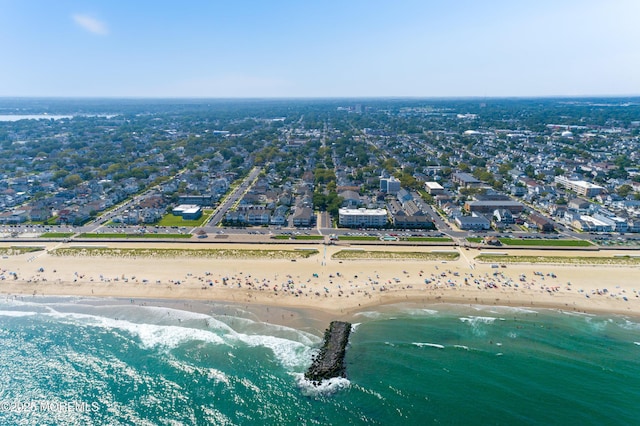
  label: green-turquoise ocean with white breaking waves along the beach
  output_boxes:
[0,297,640,425]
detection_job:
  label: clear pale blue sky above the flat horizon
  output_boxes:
[0,0,640,98]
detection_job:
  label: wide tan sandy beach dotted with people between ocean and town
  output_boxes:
[0,243,640,317]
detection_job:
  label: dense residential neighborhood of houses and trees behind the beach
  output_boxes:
[0,99,640,241]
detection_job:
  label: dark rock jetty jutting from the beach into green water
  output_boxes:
[304,321,351,385]
